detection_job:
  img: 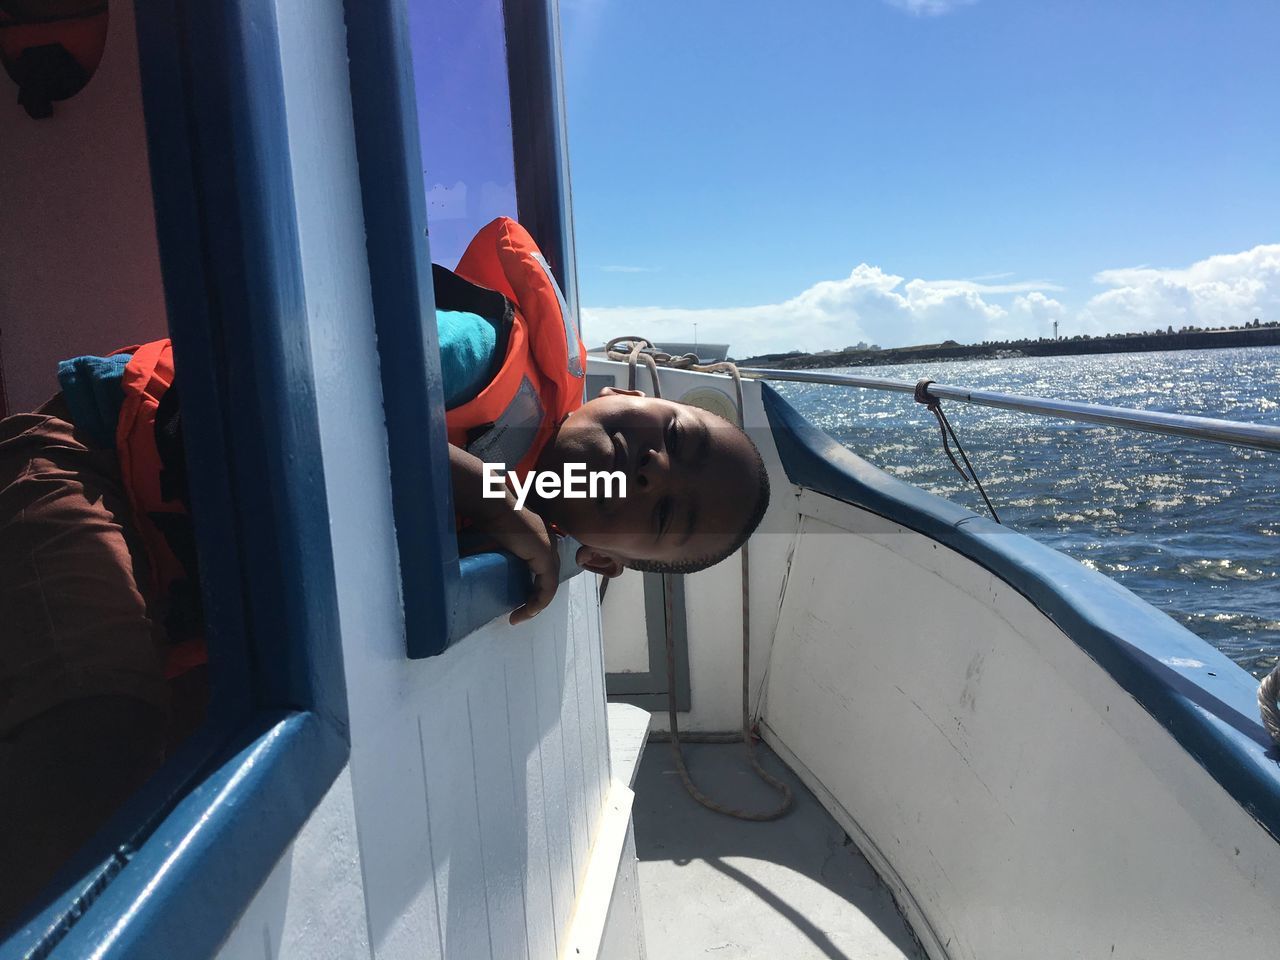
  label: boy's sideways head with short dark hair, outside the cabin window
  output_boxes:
[536,387,769,576]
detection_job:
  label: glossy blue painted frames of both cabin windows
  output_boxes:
[0,0,577,960]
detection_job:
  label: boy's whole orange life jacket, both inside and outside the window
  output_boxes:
[115,218,586,678]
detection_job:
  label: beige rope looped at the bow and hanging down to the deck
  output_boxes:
[602,337,792,822]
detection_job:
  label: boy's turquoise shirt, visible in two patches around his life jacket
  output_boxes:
[58,310,502,449]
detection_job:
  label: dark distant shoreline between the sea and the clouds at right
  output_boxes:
[736,321,1280,370]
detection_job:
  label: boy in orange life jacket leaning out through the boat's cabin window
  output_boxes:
[0,220,768,927]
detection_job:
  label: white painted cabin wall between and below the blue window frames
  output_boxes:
[217,0,608,960]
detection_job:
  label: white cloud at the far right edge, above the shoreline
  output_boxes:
[1079,243,1280,333]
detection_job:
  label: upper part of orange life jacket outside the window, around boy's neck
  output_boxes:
[445,216,586,475]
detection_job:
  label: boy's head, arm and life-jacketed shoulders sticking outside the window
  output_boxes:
[435,218,768,623]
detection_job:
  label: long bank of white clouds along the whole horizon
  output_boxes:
[582,244,1280,357]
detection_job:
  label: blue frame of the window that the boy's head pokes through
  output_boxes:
[346,0,577,659]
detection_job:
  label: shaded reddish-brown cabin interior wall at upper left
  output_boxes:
[0,0,168,412]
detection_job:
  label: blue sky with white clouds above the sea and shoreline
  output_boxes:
[561,0,1280,357]
